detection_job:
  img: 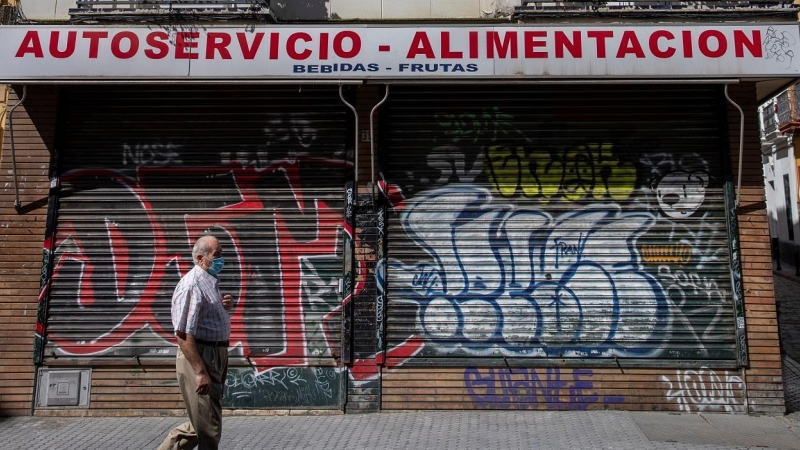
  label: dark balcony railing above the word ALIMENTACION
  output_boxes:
[515,0,800,18]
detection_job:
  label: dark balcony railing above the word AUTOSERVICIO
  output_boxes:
[69,0,274,22]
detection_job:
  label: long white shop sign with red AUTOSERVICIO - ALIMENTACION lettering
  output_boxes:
[0,24,800,82]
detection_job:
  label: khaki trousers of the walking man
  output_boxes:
[158,344,228,450]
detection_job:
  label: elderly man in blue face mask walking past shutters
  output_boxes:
[158,236,233,450]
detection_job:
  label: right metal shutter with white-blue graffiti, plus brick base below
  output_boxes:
[381,85,741,409]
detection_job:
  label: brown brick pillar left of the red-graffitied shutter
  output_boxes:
[0,87,58,416]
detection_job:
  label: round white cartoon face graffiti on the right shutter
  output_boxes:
[653,172,708,219]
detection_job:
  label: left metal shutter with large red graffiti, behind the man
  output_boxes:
[44,86,352,408]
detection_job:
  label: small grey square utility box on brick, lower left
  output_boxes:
[36,369,92,408]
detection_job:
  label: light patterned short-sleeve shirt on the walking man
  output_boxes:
[172,266,231,341]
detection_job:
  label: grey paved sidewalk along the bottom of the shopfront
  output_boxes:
[0,411,800,450]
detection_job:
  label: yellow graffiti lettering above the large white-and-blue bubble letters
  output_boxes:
[486,144,636,204]
